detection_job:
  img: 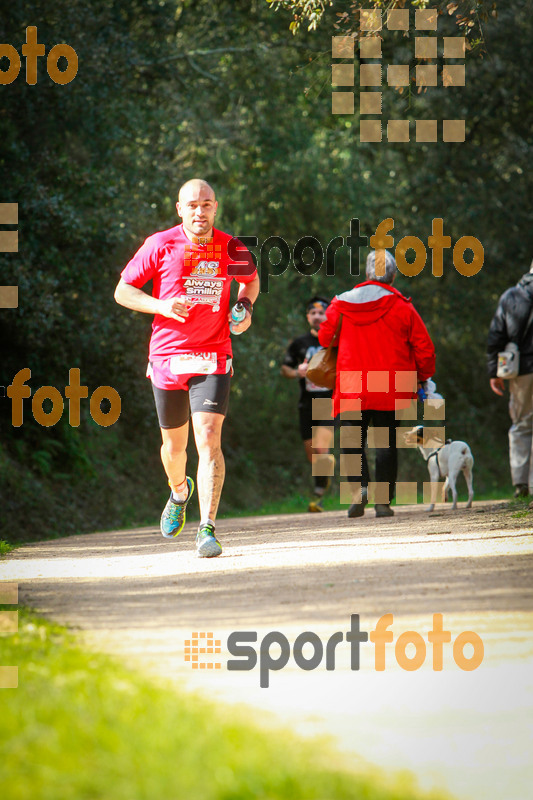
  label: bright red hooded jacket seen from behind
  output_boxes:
[318,281,435,414]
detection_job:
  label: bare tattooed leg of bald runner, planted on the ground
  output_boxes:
[192,411,226,523]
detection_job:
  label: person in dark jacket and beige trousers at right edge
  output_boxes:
[487,262,533,497]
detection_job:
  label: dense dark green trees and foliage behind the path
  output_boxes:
[0,0,533,541]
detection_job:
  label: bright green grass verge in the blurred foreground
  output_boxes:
[0,607,448,800]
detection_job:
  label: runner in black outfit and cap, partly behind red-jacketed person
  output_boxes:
[281,297,334,511]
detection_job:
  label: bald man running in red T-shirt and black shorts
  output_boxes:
[115,178,259,558]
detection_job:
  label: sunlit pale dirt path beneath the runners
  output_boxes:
[0,503,533,800]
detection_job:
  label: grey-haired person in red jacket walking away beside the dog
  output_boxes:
[318,250,435,517]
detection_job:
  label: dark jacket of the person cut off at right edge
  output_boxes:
[487,272,533,378]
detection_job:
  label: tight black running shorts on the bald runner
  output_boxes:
[152,372,231,428]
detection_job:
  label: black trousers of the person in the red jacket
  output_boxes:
[336,409,398,503]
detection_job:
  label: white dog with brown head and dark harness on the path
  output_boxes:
[404,425,474,511]
